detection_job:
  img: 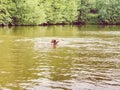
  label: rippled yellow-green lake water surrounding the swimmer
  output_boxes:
[0,26,120,90]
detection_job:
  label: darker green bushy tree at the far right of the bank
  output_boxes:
[99,0,120,24]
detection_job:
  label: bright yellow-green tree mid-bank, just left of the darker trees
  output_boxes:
[44,0,78,24]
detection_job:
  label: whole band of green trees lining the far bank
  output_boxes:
[0,0,120,26]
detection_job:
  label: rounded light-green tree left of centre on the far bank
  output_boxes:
[14,0,46,25]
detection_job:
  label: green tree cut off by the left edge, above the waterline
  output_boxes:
[0,0,15,25]
